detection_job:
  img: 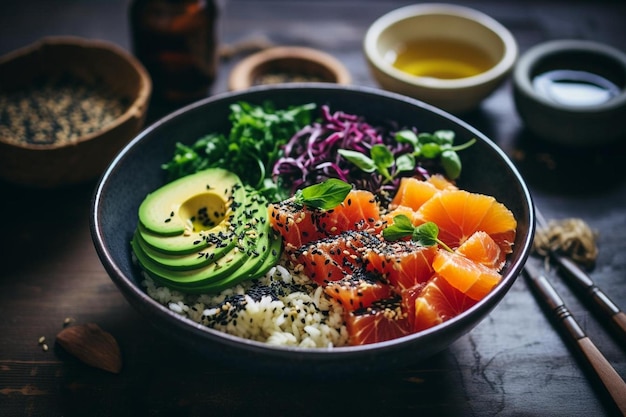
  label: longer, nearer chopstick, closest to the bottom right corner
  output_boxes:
[524,261,626,416]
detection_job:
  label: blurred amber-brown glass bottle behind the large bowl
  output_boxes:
[129,0,219,105]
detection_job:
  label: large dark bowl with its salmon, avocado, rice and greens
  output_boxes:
[90,83,534,376]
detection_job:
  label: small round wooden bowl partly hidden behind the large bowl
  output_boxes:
[228,46,351,91]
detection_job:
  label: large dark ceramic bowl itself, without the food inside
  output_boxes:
[90,84,534,376]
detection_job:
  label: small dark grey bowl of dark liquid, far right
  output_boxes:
[513,39,626,147]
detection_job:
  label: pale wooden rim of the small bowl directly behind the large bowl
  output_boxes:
[228,45,351,91]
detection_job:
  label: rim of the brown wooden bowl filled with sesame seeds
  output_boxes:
[0,35,152,151]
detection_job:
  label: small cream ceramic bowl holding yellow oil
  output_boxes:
[363,3,518,113]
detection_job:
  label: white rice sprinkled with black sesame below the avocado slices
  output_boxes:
[142,258,348,348]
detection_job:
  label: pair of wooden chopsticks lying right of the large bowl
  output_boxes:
[524,212,626,416]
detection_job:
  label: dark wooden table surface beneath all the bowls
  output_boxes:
[0,0,626,417]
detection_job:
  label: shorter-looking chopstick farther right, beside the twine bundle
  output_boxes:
[535,208,626,346]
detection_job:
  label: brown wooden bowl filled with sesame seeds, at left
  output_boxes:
[0,37,152,188]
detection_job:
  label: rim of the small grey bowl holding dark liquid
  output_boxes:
[513,39,626,115]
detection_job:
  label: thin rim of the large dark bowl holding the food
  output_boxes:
[90,83,535,362]
